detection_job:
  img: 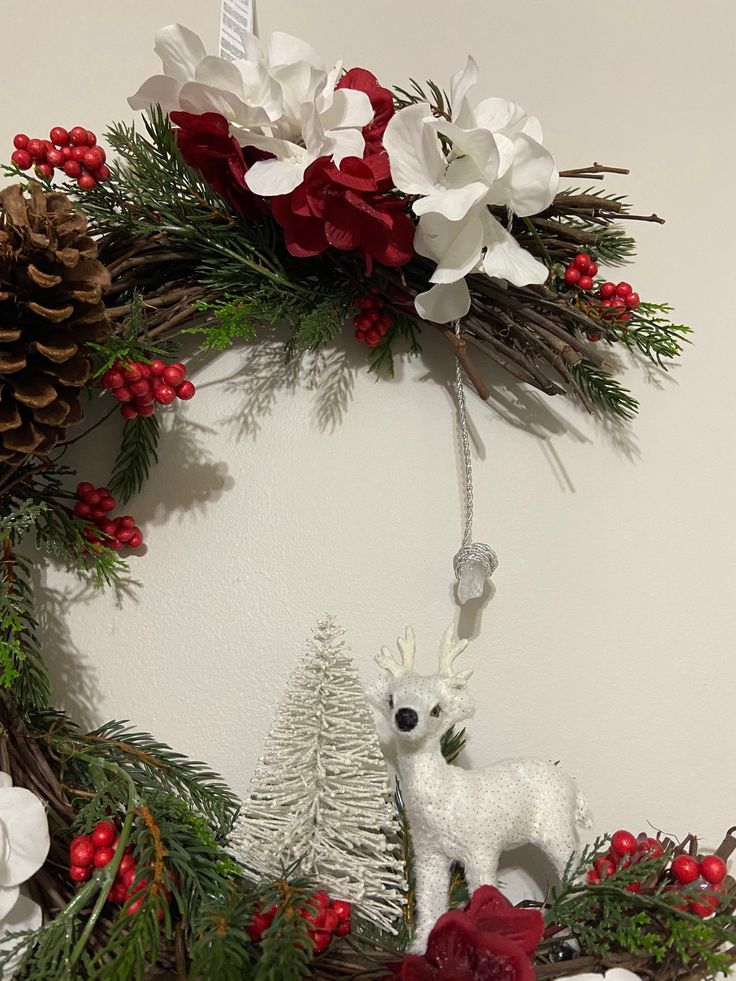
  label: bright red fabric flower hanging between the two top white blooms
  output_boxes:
[271,150,414,273]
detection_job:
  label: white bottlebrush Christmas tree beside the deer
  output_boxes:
[231,617,404,930]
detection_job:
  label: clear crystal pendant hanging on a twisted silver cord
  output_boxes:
[453,320,498,606]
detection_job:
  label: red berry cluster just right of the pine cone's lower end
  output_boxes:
[101,360,196,419]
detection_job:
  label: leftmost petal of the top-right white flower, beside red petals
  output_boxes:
[383,103,445,194]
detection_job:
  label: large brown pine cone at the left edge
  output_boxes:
[0,182,111,465]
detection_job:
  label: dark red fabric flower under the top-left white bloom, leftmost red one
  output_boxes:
[169,110,268,218]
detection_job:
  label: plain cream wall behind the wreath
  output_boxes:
[0,0,736,884]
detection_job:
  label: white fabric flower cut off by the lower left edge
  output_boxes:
[0,772,50,977]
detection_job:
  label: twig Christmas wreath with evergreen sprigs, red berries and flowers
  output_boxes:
[0,19,736,981]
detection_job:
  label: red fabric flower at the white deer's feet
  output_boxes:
[395,911,534,981]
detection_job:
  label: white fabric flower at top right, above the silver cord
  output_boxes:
[384,58,559,323]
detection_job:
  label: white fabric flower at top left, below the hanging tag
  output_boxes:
[128,24,373,196]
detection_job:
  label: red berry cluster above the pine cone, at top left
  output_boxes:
[10,126,110,191]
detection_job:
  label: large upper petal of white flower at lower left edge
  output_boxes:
[0,787,50,886]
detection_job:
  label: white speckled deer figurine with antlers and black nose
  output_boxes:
[376,624,592,953]
